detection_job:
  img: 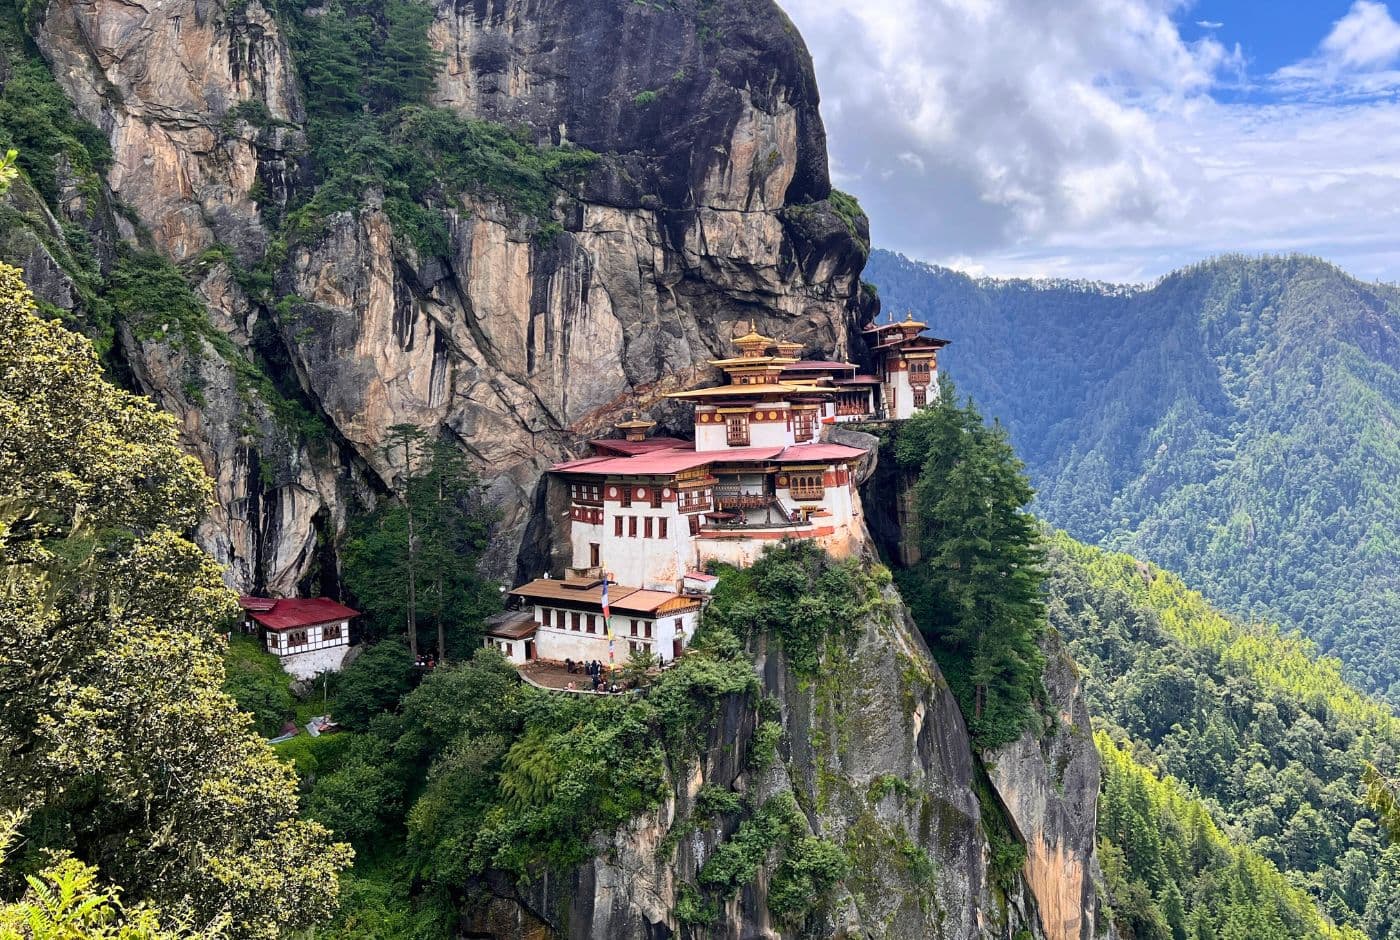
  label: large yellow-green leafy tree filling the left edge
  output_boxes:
[0,266,350,937]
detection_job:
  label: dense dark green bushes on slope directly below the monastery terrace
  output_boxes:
[291,630,757,937]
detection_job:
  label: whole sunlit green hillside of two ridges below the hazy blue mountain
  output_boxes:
[1046,534,1400,940]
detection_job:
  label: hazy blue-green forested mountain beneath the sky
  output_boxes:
[865,251,1400,702]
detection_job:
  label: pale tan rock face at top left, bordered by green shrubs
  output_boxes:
[35,0,304,261]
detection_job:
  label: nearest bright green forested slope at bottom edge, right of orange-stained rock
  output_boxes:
[1095,731,1365,940]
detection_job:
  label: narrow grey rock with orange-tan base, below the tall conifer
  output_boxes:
[986,633,1099,940]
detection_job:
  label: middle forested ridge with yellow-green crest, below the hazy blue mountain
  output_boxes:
[1047,535,1400,940]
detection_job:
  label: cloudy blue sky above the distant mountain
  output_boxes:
[781,0,1400,280]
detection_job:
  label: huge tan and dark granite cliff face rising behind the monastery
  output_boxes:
[31,0,867,593]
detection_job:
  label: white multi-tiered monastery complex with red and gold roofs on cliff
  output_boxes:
[486,315,948,664]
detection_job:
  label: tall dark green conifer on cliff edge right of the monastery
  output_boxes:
[895,378,1044,747]
